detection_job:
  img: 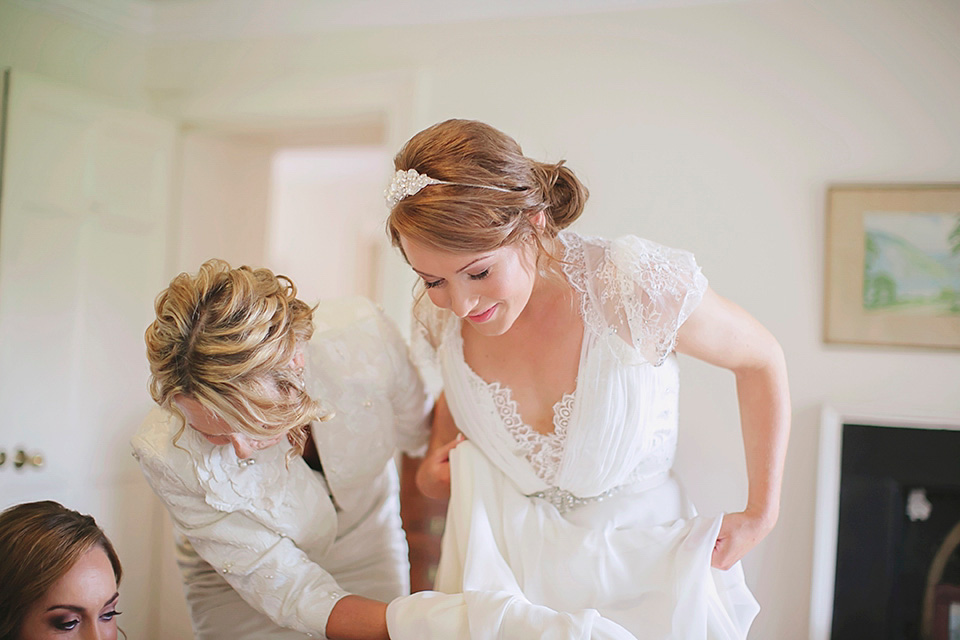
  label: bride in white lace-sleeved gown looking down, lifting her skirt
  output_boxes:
[387,120,790,639]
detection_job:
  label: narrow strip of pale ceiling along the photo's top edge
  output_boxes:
[17,0,742,40]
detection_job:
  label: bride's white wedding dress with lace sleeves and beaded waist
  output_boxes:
[388,232,759,640]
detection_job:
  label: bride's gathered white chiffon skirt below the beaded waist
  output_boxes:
[387,442,759,640]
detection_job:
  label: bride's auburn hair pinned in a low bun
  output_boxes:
[387,120,589,261]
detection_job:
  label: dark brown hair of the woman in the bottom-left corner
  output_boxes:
[0,500,123,638]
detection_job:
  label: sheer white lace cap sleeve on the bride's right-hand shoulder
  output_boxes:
[599,236,707,365]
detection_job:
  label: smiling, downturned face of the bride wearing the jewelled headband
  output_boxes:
[400,232,537,336]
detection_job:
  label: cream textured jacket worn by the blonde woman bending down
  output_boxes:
[132,299,431,637]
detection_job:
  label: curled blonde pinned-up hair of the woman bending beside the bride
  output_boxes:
[145,260,326,459]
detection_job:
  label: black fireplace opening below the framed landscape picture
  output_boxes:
[831,424,960,640]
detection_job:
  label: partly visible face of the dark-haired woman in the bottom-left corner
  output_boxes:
[19,545,120,640]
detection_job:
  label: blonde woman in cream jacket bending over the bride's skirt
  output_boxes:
[132,260,430,640]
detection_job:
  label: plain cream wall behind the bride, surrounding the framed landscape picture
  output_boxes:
[149,0,960,638]
